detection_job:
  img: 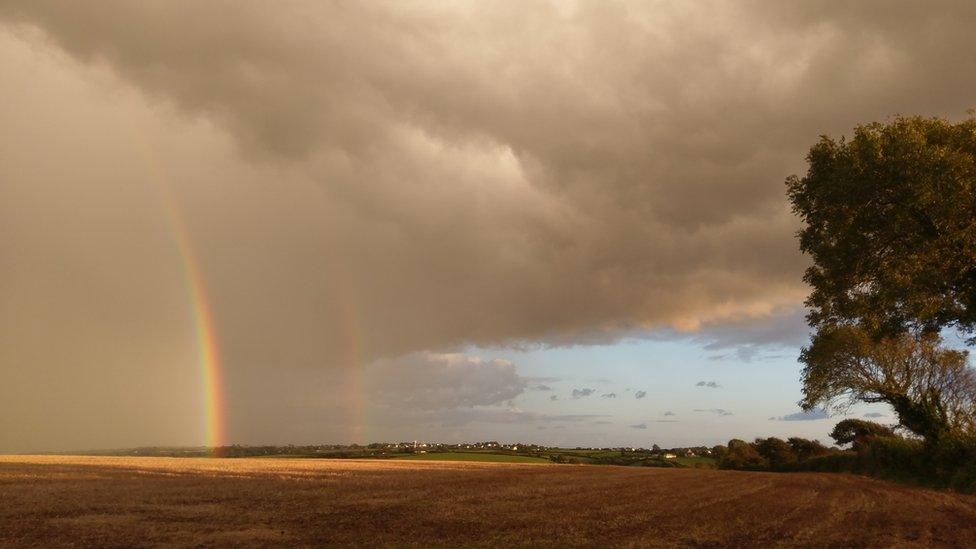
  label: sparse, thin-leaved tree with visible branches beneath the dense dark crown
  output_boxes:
[800,326,976,441]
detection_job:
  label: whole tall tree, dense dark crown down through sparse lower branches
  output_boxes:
[787,111,976,440]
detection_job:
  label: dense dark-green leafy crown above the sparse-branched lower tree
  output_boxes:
[786,111,976,337]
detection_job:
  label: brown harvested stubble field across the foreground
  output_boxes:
[0,456,976,547]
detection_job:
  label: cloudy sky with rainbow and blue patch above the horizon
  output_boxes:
[0,0,976,452]
